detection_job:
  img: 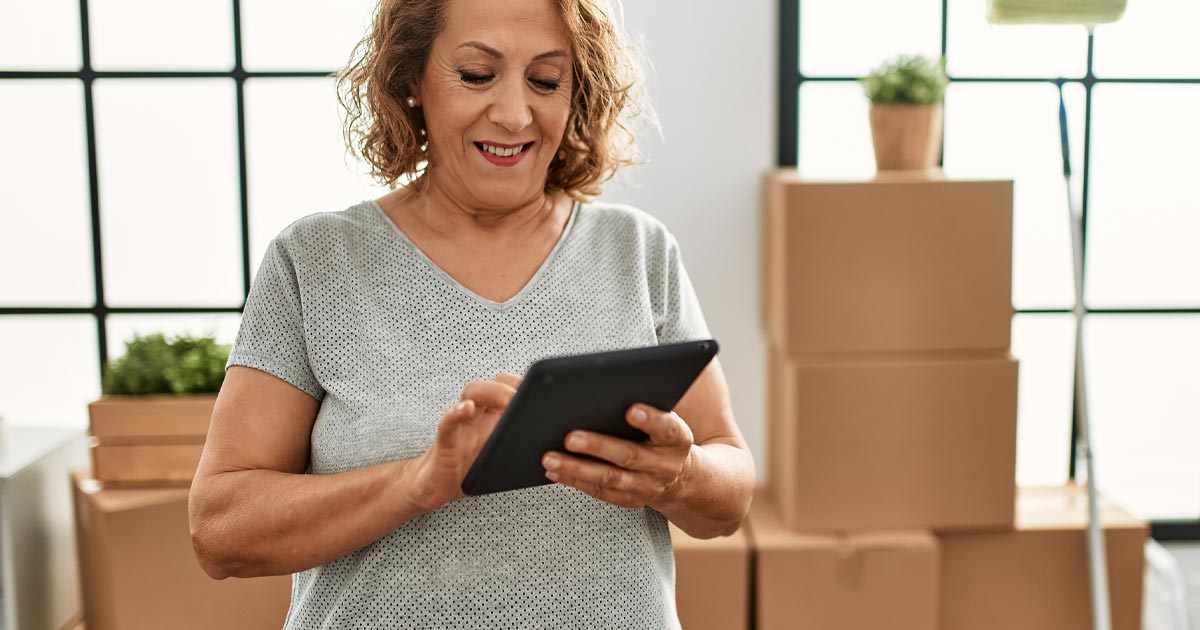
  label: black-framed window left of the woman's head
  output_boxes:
[0,0,385,427]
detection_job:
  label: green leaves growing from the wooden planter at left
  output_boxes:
[102,332,230,396]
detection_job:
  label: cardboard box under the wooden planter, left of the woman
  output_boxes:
[71,473,292,630]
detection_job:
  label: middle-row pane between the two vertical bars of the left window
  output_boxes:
[95,79,242,306]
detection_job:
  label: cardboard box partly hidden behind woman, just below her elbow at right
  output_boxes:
[671,524,750,630]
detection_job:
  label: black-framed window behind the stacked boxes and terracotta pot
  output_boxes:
[778,0,1200,539]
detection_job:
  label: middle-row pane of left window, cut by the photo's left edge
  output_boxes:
[0,80,96,306]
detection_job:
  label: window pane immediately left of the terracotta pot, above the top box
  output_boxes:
[797,82,875,178]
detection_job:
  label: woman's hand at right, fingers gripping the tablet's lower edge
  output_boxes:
[541,404,695,508]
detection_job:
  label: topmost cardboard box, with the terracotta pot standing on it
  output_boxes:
[762,169,1014,355]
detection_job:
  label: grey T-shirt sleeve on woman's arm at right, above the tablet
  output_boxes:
[649,233,710,344]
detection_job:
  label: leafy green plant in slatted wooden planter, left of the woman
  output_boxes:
[88,334,229,485]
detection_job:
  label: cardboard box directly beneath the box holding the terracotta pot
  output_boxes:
[767,353,1018,532]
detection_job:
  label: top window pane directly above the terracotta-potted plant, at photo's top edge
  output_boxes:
[800,0,942,77]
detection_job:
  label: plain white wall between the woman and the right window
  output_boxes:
[605,0,779,479]
